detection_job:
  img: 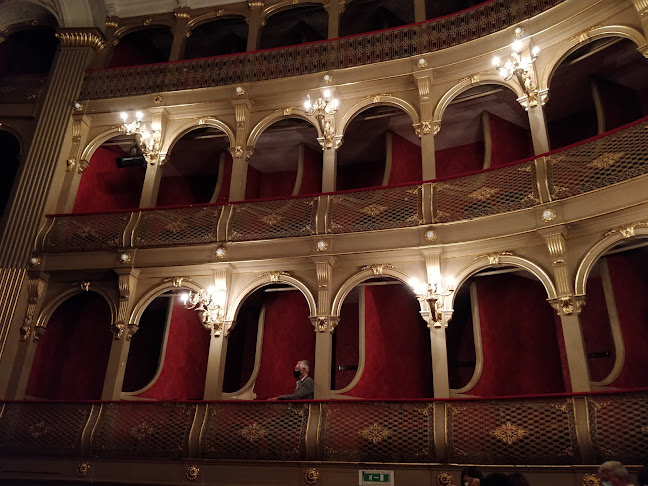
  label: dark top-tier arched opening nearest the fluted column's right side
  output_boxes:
[108,25,173,67]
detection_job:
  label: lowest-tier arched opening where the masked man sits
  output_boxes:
[223,284,315,399]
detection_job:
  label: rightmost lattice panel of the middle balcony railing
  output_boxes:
[547,122,648,199]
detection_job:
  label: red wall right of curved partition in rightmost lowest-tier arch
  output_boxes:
[604,252,648,388]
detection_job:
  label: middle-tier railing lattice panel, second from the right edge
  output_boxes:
[432,161,540,223]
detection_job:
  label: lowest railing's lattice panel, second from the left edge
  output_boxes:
[93,403,196,458]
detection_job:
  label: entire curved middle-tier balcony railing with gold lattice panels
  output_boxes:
[37,119,648,252]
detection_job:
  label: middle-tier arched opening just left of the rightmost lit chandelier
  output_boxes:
[434,84,533,178]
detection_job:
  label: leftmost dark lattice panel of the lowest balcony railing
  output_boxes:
[0,402,92,456]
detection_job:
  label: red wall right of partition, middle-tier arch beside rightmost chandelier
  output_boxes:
[488,113,533,167]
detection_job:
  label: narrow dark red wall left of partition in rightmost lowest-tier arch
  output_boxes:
[580,275,616,381]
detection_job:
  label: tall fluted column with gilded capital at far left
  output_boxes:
[0,29,105,395]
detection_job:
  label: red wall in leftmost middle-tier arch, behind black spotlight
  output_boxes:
[73,147,146,213]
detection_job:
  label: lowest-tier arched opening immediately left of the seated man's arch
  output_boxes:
[122,289,210,400]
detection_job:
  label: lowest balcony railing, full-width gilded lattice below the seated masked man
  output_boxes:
[0,391,648,465]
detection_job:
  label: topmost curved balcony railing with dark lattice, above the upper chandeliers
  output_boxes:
[80,0,565,99]
